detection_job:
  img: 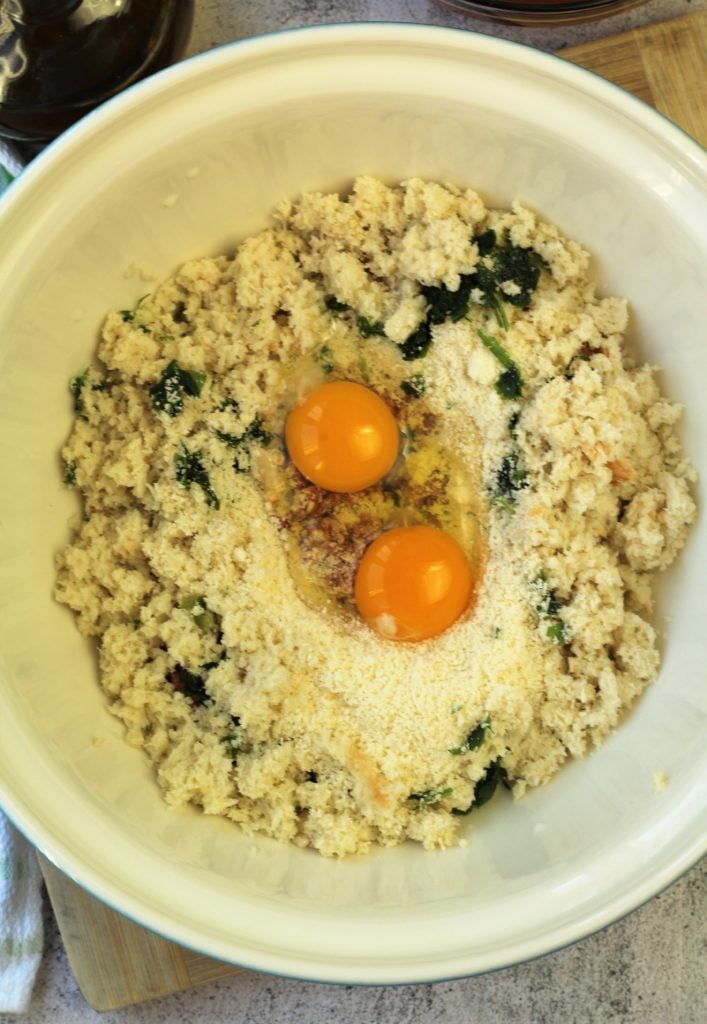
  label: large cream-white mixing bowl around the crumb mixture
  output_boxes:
[0,25,707,983]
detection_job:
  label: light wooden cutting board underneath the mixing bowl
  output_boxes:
[39,12,707,1010]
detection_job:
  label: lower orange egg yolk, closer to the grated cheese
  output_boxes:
[354,526,473,641]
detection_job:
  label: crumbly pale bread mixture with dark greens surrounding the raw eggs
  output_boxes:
[56,177,695,856]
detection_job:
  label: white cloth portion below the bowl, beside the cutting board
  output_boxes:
[0,811,44,1014]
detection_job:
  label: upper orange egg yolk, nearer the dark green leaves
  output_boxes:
[285,381,400,494]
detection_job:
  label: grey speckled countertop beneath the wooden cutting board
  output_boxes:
[14,0,707,1024]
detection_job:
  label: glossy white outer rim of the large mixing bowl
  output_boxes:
[0,22,707,985]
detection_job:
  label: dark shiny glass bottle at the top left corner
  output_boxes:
[0,0,194,153]
